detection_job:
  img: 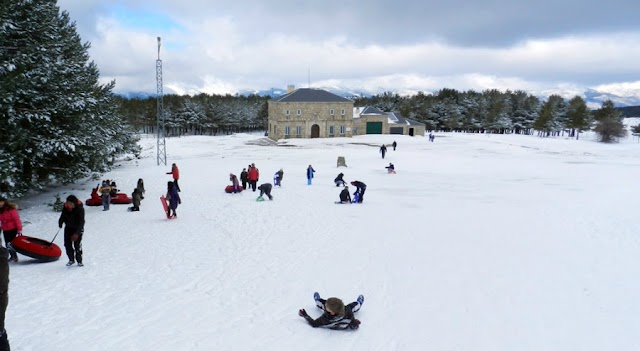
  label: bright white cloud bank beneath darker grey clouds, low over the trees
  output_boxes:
[58,0,640,94]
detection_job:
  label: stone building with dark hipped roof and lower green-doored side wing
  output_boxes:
[268,87,425,140]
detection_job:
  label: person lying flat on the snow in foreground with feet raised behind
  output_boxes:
[298,292,364,330]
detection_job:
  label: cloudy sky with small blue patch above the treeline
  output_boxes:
[58,0,640,95]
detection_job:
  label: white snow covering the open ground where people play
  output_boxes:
[6,133,640,351]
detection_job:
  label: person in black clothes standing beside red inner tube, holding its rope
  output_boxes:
[58,195,84,267]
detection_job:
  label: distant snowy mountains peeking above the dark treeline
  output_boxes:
[118,86,640,108]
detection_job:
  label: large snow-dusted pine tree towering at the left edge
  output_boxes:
[0,0,137,196]
